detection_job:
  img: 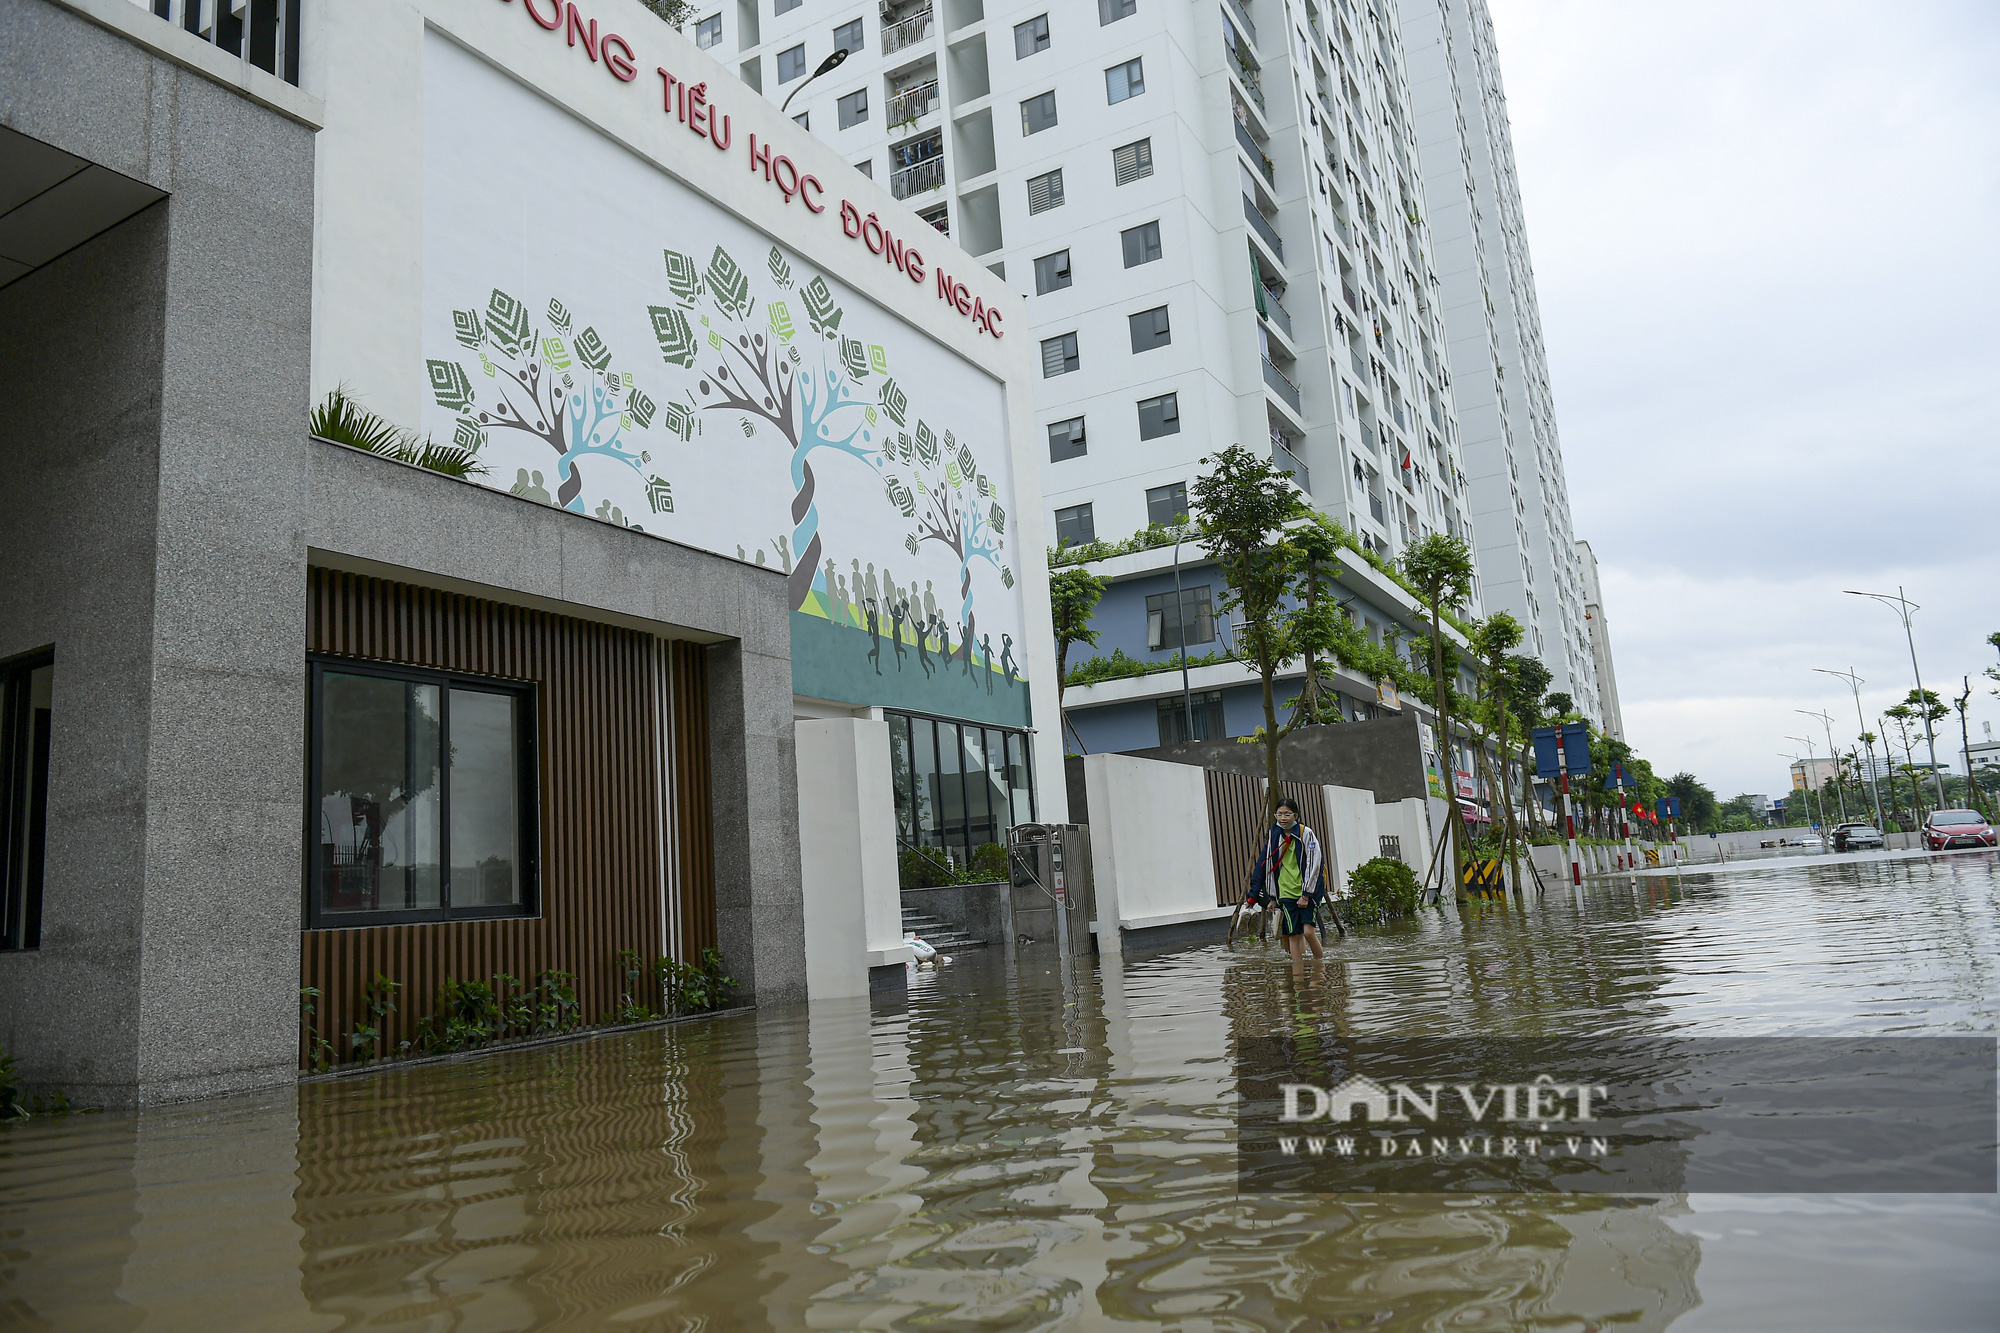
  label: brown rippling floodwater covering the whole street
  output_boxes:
[0,853,2000,1333]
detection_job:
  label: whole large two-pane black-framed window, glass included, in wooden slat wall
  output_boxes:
[306,660,538,929]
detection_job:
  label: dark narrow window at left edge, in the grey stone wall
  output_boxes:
[0,650,56,951]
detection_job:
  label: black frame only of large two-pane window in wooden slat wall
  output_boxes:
[300,652,542,931]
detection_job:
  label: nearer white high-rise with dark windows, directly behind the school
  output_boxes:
[720,0,1472,556]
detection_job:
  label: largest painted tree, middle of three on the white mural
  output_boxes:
[648,246,886,610]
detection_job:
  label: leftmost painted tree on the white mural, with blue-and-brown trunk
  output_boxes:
[424,288,656,512]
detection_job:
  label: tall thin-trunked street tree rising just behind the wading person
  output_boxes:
[1190,444,1306,823]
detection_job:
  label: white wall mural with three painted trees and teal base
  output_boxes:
[422,34,1032,727]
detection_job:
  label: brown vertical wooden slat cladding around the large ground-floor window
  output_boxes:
[300,570,714,1057]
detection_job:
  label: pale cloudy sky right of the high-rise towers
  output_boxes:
[1490,0,2000,799]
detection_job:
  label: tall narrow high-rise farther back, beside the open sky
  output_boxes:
[1396,0,1592,727]
